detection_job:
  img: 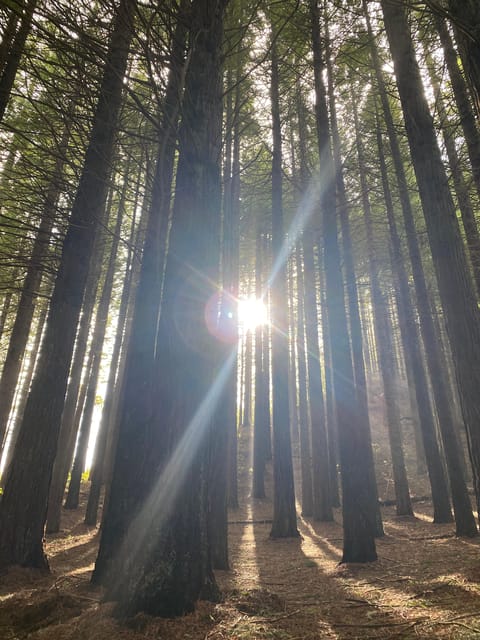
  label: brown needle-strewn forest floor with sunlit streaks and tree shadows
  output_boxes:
[0,422,480,640]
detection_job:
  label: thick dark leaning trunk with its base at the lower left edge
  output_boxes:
[0,0,135,568]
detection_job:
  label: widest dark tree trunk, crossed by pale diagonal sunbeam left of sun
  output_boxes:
[94,0,229,616]
